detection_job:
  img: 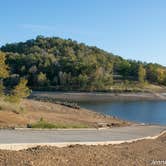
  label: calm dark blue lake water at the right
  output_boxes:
[80,101,166,125]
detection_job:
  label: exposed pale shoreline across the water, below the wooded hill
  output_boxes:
[30,91,166,102]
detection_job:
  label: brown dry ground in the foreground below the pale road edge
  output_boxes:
[0,134,166,166]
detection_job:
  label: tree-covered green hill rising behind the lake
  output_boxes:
[1,36,166,90]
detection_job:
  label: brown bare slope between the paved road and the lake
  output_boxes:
[0,99,131,128]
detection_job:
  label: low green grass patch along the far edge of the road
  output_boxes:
[27,118,88,129]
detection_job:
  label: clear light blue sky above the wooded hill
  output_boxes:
[0,0,166,66]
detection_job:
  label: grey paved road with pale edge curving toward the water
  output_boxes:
[0,125,166,150]
